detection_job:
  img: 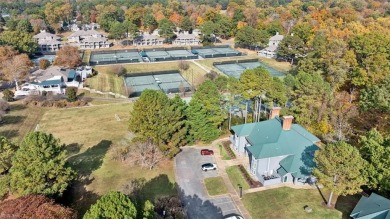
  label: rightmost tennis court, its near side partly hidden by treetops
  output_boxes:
[214,60,285,79]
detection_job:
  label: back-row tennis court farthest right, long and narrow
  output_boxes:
[192,46,245,58]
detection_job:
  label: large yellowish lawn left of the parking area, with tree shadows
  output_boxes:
[40,103,177,215]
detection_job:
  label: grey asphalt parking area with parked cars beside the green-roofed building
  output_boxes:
[175,147,238,219]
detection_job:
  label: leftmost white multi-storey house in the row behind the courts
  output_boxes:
[33,30,62,53]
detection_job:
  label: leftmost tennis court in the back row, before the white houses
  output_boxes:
[89,50,141,65]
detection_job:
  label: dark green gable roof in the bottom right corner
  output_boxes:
[350,193,390,219]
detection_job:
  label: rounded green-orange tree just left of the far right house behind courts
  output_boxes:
[235,26,268,46]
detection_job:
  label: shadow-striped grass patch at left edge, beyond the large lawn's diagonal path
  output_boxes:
[0,101,47,143]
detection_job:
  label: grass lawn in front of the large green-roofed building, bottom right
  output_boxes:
[242,187,342,219]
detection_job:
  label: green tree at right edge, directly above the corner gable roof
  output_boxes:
[359,129,390,194]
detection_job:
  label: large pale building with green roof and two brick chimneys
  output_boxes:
[230,108,320,186]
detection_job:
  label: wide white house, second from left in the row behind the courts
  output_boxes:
[68,30,112,49]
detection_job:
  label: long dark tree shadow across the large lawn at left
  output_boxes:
[60,140,112,218]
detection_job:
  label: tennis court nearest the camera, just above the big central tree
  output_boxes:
[125,71,191,97]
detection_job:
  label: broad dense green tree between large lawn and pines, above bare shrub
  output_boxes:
[129,90,187,157]
